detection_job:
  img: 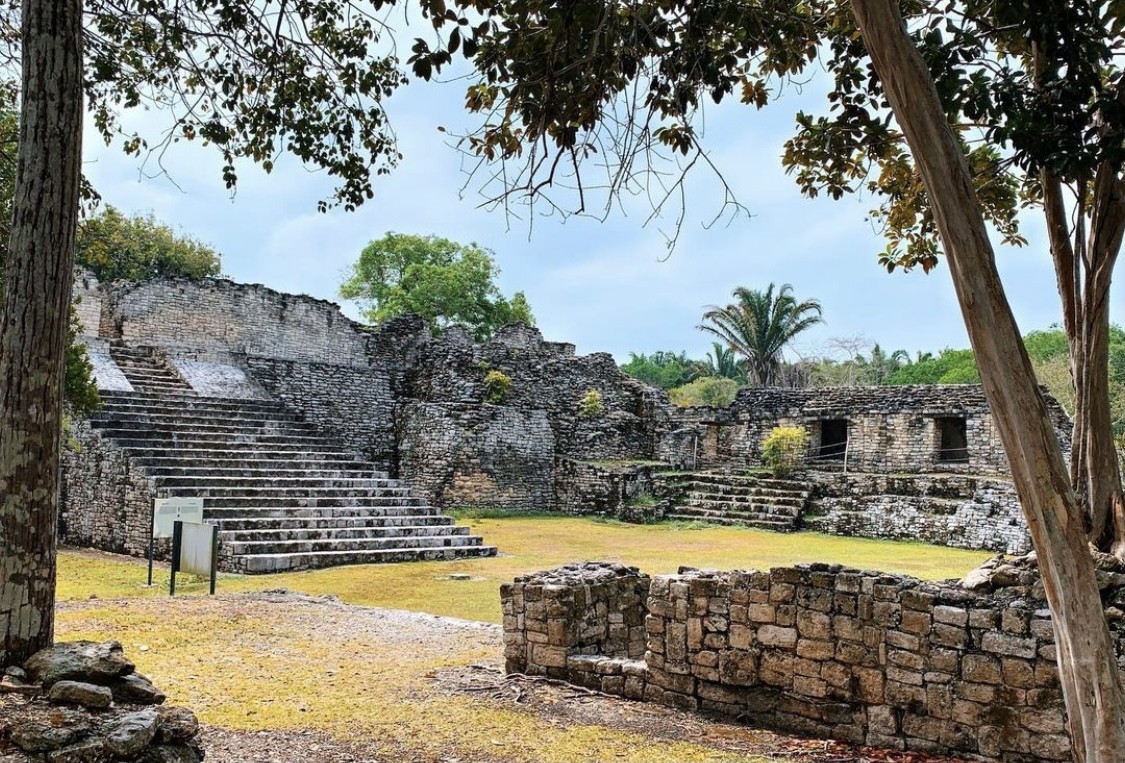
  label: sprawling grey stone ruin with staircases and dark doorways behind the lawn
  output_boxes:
[61,276,1069,572]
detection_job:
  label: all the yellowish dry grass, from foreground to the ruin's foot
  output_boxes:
[57,518,988,763]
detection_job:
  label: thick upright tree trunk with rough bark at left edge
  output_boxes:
[0,0,82,666]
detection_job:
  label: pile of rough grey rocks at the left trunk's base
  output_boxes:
[0,641,204,763]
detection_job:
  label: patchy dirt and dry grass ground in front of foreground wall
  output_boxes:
[0,591,976,763]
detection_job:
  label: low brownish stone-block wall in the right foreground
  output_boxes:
[501,564,1071,763]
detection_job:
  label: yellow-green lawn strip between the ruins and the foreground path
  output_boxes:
[59,517,991,622]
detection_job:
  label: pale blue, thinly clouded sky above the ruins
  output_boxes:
[83,57,1125,362]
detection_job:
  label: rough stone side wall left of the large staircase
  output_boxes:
[59,421,156,556]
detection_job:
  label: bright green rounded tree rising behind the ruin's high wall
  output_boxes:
[340,233,534,341]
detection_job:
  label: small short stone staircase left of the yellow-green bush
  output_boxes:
[665,472,811,532]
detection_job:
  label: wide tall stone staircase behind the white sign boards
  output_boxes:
[91,393,496,573]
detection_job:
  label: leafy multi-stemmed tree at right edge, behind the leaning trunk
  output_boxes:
[784,0,1125,560]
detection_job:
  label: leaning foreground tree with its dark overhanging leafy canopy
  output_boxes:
[412,0,1125,762]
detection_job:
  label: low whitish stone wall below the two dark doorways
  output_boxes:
[803,472,1032,554]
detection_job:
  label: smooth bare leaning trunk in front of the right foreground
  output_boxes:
[852,0,1125,763]
